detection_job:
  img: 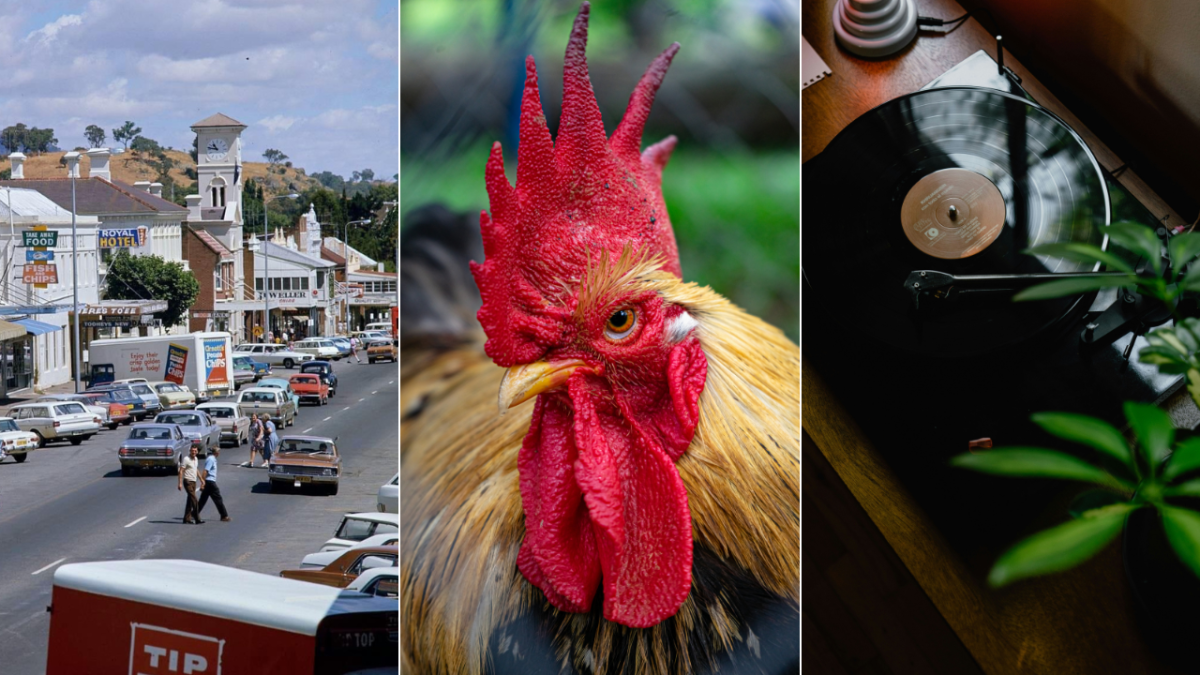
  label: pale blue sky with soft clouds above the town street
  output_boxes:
[0,0,400,180]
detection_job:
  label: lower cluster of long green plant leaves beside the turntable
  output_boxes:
[950,402,1200,587]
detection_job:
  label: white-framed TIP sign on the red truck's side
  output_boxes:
[130,623,224,675]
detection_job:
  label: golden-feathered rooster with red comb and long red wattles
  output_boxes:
[401,2,800,675]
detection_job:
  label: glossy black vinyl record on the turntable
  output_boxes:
[802,86,1110,357]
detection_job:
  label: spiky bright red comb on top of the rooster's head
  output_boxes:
[472,2,680,368]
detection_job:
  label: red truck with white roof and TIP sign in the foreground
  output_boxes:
[46,560,400,675]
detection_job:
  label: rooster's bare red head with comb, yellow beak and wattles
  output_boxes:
[472,2,708,627]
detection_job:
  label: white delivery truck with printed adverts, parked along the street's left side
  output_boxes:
[88,333,234,402]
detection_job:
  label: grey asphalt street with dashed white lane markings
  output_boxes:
[0,360,400,675]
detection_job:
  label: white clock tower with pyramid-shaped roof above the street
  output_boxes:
[188,113,254,335]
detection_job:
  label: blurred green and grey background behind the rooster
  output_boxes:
[401,0,800,340]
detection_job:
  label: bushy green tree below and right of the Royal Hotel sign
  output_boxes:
[104,249,200,325]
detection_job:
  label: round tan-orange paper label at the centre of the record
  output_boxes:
[900,168,1004,259]
